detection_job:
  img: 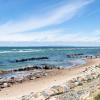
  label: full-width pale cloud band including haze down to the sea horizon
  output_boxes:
[0,26,100,46]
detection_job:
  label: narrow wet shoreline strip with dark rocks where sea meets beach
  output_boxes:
[0,59,87,78]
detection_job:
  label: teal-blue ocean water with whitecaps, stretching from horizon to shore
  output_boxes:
[0,47,100,70]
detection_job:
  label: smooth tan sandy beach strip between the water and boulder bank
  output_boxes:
[0,58,100,100]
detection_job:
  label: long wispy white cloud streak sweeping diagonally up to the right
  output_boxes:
[0,0,94,35]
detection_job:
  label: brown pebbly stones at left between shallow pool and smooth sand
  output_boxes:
[0,70,47,90]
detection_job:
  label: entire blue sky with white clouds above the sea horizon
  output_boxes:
[0,0,100,46]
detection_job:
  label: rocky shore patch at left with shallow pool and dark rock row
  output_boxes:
[0,64,61,91]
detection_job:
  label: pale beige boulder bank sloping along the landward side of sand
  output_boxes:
[20,65,100,100]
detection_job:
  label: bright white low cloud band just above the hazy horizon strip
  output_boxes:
[0,29,100,44]
